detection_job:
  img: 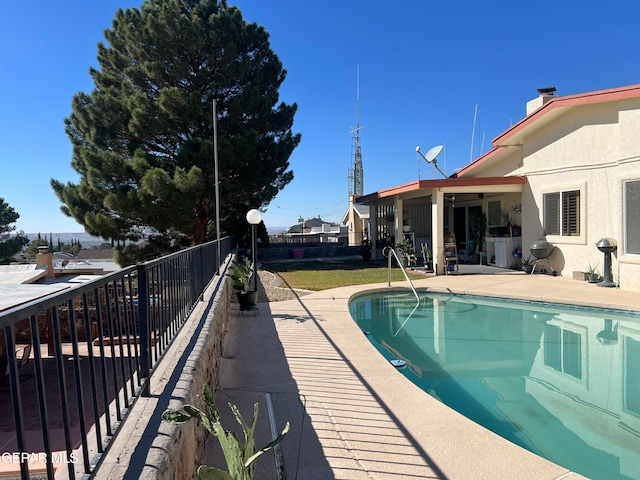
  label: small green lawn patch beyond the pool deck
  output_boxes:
[262,260,424,291]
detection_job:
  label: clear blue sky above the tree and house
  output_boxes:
[0,0,640,233]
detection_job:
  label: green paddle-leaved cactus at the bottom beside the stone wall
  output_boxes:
[162,385,289,480]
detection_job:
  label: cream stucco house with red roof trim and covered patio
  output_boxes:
[356,85,640,291]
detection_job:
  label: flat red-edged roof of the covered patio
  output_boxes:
[356,176,525,203]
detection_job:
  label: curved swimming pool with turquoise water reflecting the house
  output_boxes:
[349,291,640,479]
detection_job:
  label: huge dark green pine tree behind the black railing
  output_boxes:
[51,0,300,263]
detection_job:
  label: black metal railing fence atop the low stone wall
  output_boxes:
[0,238,234,479]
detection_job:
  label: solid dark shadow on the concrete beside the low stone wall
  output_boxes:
[210,303,335,480]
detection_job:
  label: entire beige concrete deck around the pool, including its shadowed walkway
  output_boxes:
[212,274,640,480]
